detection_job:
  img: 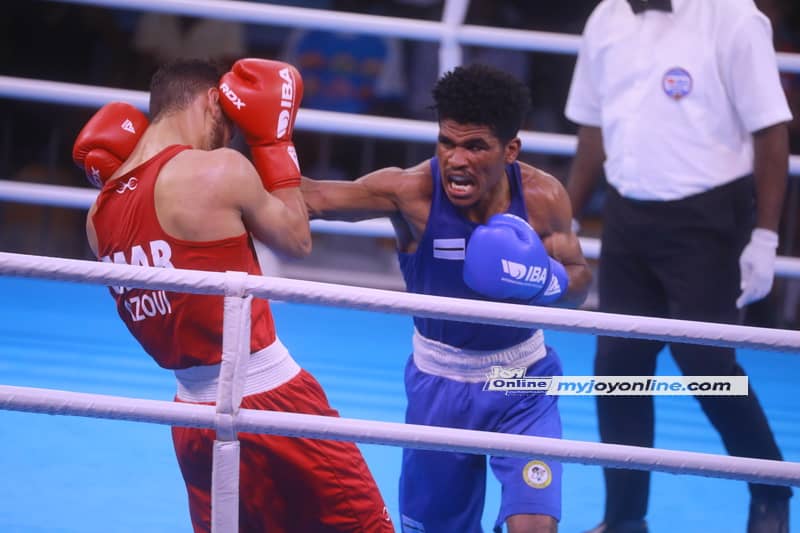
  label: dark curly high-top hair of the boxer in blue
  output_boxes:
[433,64,531,142]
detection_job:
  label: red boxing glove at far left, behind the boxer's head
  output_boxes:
[72,102,148,189]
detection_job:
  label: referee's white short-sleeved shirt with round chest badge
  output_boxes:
[566,0,792,200]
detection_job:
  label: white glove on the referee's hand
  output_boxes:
[736,228,778,309]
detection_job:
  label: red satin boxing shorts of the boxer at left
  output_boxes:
[172,370,394,533]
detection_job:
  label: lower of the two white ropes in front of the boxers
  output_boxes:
[0,385,800,486]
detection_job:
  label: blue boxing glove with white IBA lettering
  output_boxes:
[464,213,569,305]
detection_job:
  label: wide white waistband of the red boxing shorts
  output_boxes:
[175,338,300,402]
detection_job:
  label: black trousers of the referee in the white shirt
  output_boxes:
[595,177,791,524]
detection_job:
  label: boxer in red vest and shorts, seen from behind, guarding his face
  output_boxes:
[73,59,393,532]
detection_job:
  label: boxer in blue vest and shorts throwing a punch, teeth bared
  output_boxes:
[301,65,591,533]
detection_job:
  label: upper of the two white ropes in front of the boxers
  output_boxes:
[0,253,800,352]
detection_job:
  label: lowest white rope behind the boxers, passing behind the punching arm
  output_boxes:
[0,180,800,279]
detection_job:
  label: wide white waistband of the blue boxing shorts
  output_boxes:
[412,329,547,383]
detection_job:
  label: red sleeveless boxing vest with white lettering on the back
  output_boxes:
[92,145,275,369]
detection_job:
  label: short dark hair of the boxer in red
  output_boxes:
[150,59,224,122]
